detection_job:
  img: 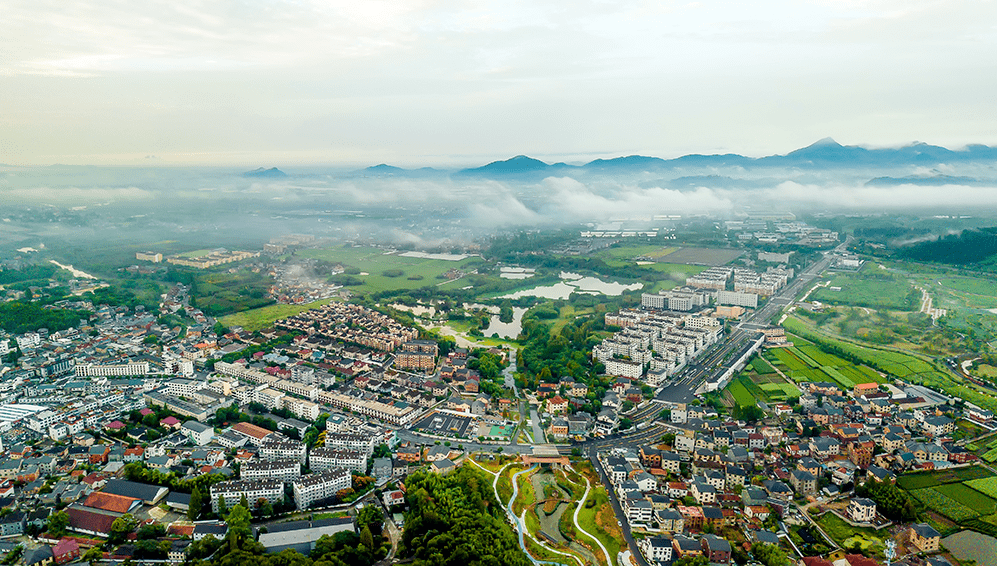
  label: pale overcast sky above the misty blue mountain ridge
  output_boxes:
[0,0,997,167]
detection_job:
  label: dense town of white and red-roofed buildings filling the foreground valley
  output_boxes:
[0,223,997,566]
